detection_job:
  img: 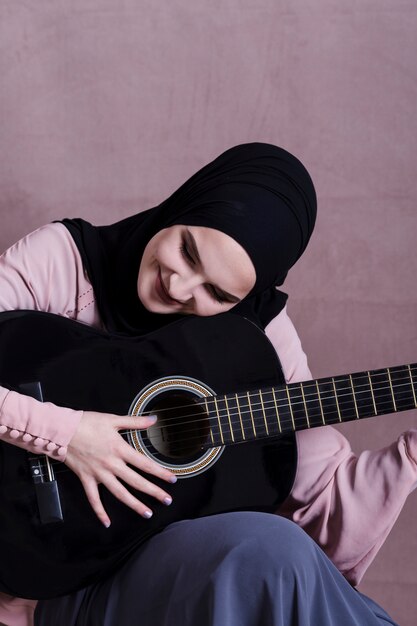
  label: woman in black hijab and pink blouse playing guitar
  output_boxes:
[0,143,417,626]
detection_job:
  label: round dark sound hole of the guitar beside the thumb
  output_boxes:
[146,391,210,459]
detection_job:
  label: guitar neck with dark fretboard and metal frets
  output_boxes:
[205,364,417,446]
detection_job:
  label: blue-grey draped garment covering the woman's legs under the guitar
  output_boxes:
[35,512,396,626]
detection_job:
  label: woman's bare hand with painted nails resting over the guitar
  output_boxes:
[65,411,177,527]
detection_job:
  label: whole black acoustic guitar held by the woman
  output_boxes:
[0,311,417,598]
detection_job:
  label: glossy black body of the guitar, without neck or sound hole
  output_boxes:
[0,311,296,599]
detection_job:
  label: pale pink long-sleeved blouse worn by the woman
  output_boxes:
[0,224,417,626]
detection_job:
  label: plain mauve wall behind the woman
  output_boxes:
[0,0,417,626]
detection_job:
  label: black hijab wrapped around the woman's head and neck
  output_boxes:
[63,143,316,335]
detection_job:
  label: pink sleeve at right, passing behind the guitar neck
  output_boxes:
[266,309,417,585]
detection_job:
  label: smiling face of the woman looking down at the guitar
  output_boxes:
[137,225,256,315]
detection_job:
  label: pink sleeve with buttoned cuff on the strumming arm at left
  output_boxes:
[0,224,97,460]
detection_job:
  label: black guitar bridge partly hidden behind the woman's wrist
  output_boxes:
[19,382,64,524]
